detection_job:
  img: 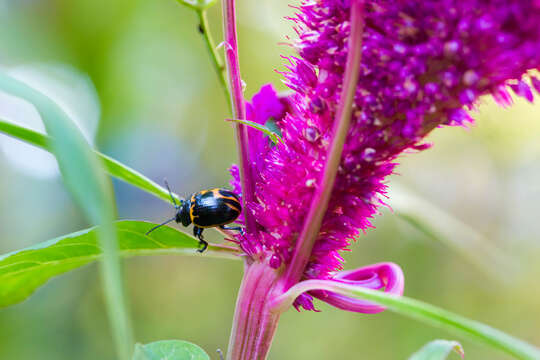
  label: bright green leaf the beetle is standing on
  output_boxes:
[0,221,239,307]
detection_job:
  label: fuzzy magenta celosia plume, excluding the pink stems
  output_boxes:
[232,0,540,309]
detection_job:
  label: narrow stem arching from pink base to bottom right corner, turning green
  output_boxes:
[273,280,540,360]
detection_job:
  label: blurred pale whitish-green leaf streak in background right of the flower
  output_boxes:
[388,182,514,281]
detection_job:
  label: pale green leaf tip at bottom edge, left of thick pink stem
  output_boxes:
[133,340,210,360]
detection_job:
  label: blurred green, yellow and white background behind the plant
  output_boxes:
[0,0,540,360]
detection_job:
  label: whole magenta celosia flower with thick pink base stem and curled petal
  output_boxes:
[220,0,540,358]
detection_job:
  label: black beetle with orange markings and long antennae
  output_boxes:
[146,180,244,253]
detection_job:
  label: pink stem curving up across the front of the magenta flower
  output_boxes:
[286,0,364,287]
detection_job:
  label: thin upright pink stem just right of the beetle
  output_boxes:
[222,0,255,233]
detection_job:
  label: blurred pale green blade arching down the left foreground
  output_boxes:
[0,73,133,360]
